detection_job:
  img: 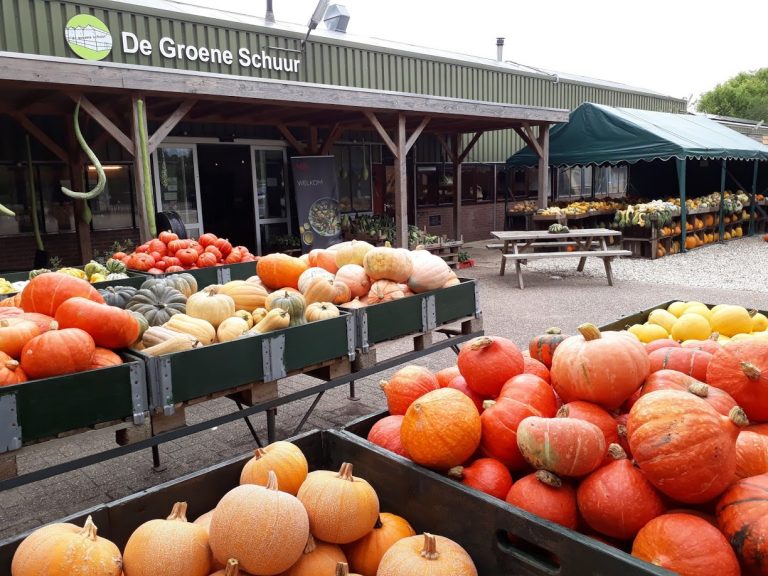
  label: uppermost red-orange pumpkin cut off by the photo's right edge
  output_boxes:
[707,339,768,422]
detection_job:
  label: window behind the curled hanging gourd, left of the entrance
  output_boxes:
[86,164,136,230]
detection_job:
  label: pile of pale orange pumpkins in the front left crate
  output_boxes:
[11,441,477,576]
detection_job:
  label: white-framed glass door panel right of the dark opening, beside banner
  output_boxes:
[252,146,291,254]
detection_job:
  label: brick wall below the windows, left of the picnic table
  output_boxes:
[416,202,504,242]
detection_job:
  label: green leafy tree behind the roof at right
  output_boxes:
[696,68,768,122]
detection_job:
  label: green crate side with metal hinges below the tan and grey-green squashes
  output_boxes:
[137,312,355,413]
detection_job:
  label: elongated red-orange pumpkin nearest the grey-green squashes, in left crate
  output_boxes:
[56,296,139,348]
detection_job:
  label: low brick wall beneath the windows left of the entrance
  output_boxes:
[0,229,139,272]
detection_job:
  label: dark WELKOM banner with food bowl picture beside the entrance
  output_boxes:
[291,156,342,253]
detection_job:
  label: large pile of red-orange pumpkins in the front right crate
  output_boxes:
[368,324,768,576]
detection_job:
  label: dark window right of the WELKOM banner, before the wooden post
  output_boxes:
[333,144,373,212]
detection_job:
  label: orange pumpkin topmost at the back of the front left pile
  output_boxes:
[240,440,309,496]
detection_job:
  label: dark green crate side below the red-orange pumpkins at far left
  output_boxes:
[0,355,148,452]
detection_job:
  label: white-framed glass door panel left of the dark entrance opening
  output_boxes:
[154,144,203,238]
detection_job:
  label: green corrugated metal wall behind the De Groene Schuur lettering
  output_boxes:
[0,0,685,162]
